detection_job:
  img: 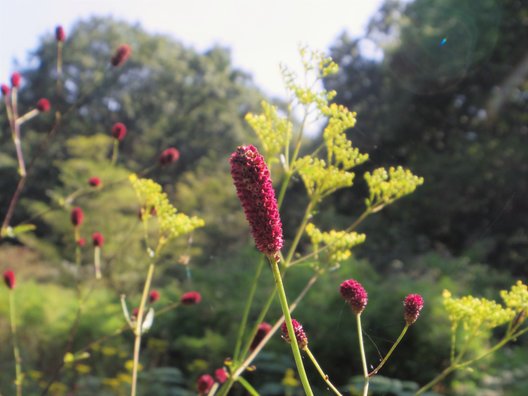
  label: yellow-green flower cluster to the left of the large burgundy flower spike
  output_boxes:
[129,174,205,242]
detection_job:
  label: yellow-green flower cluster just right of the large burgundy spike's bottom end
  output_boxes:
[306,223,366,263]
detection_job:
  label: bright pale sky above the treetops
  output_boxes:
[0,0,382,96]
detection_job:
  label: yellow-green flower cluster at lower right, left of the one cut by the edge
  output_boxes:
[443,290,515,336]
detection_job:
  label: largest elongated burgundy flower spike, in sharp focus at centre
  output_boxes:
[230,145,283,255]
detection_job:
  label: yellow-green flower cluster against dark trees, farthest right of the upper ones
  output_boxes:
[365,166,424,211]
